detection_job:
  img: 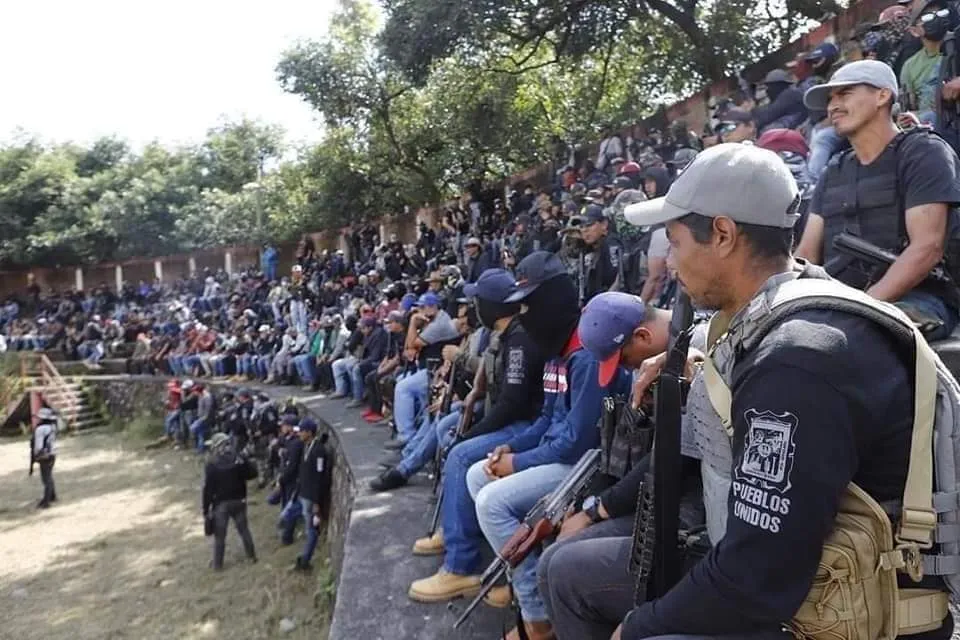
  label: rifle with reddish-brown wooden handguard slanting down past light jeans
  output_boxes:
[453,449,600,629]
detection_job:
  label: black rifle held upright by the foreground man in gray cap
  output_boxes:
[630,289,693,604]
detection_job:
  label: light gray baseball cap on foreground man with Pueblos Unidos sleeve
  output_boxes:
[623,142,800,229]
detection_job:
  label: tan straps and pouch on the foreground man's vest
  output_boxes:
[704,278,948,640]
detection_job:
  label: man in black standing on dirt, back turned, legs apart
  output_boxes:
[203,433,257,571]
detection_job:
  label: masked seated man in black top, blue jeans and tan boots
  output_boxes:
[409,269,544,602]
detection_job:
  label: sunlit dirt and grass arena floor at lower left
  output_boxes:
[0,433,330,640]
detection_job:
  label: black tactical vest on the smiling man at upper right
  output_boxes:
[816,128,960,308]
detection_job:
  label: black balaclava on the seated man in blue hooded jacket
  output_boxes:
[520,275,580,358]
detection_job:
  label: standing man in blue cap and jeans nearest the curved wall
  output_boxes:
[294,418,332,571]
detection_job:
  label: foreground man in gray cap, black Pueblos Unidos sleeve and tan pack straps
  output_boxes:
[608,144,958,640]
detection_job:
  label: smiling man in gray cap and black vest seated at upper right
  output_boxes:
[797,60,960,340]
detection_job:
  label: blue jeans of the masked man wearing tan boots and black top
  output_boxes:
[440,422,529,576]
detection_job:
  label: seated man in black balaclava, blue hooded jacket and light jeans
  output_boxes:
[432,251,627,638]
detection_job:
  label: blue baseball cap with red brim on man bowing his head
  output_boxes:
[579,291,647,387]
